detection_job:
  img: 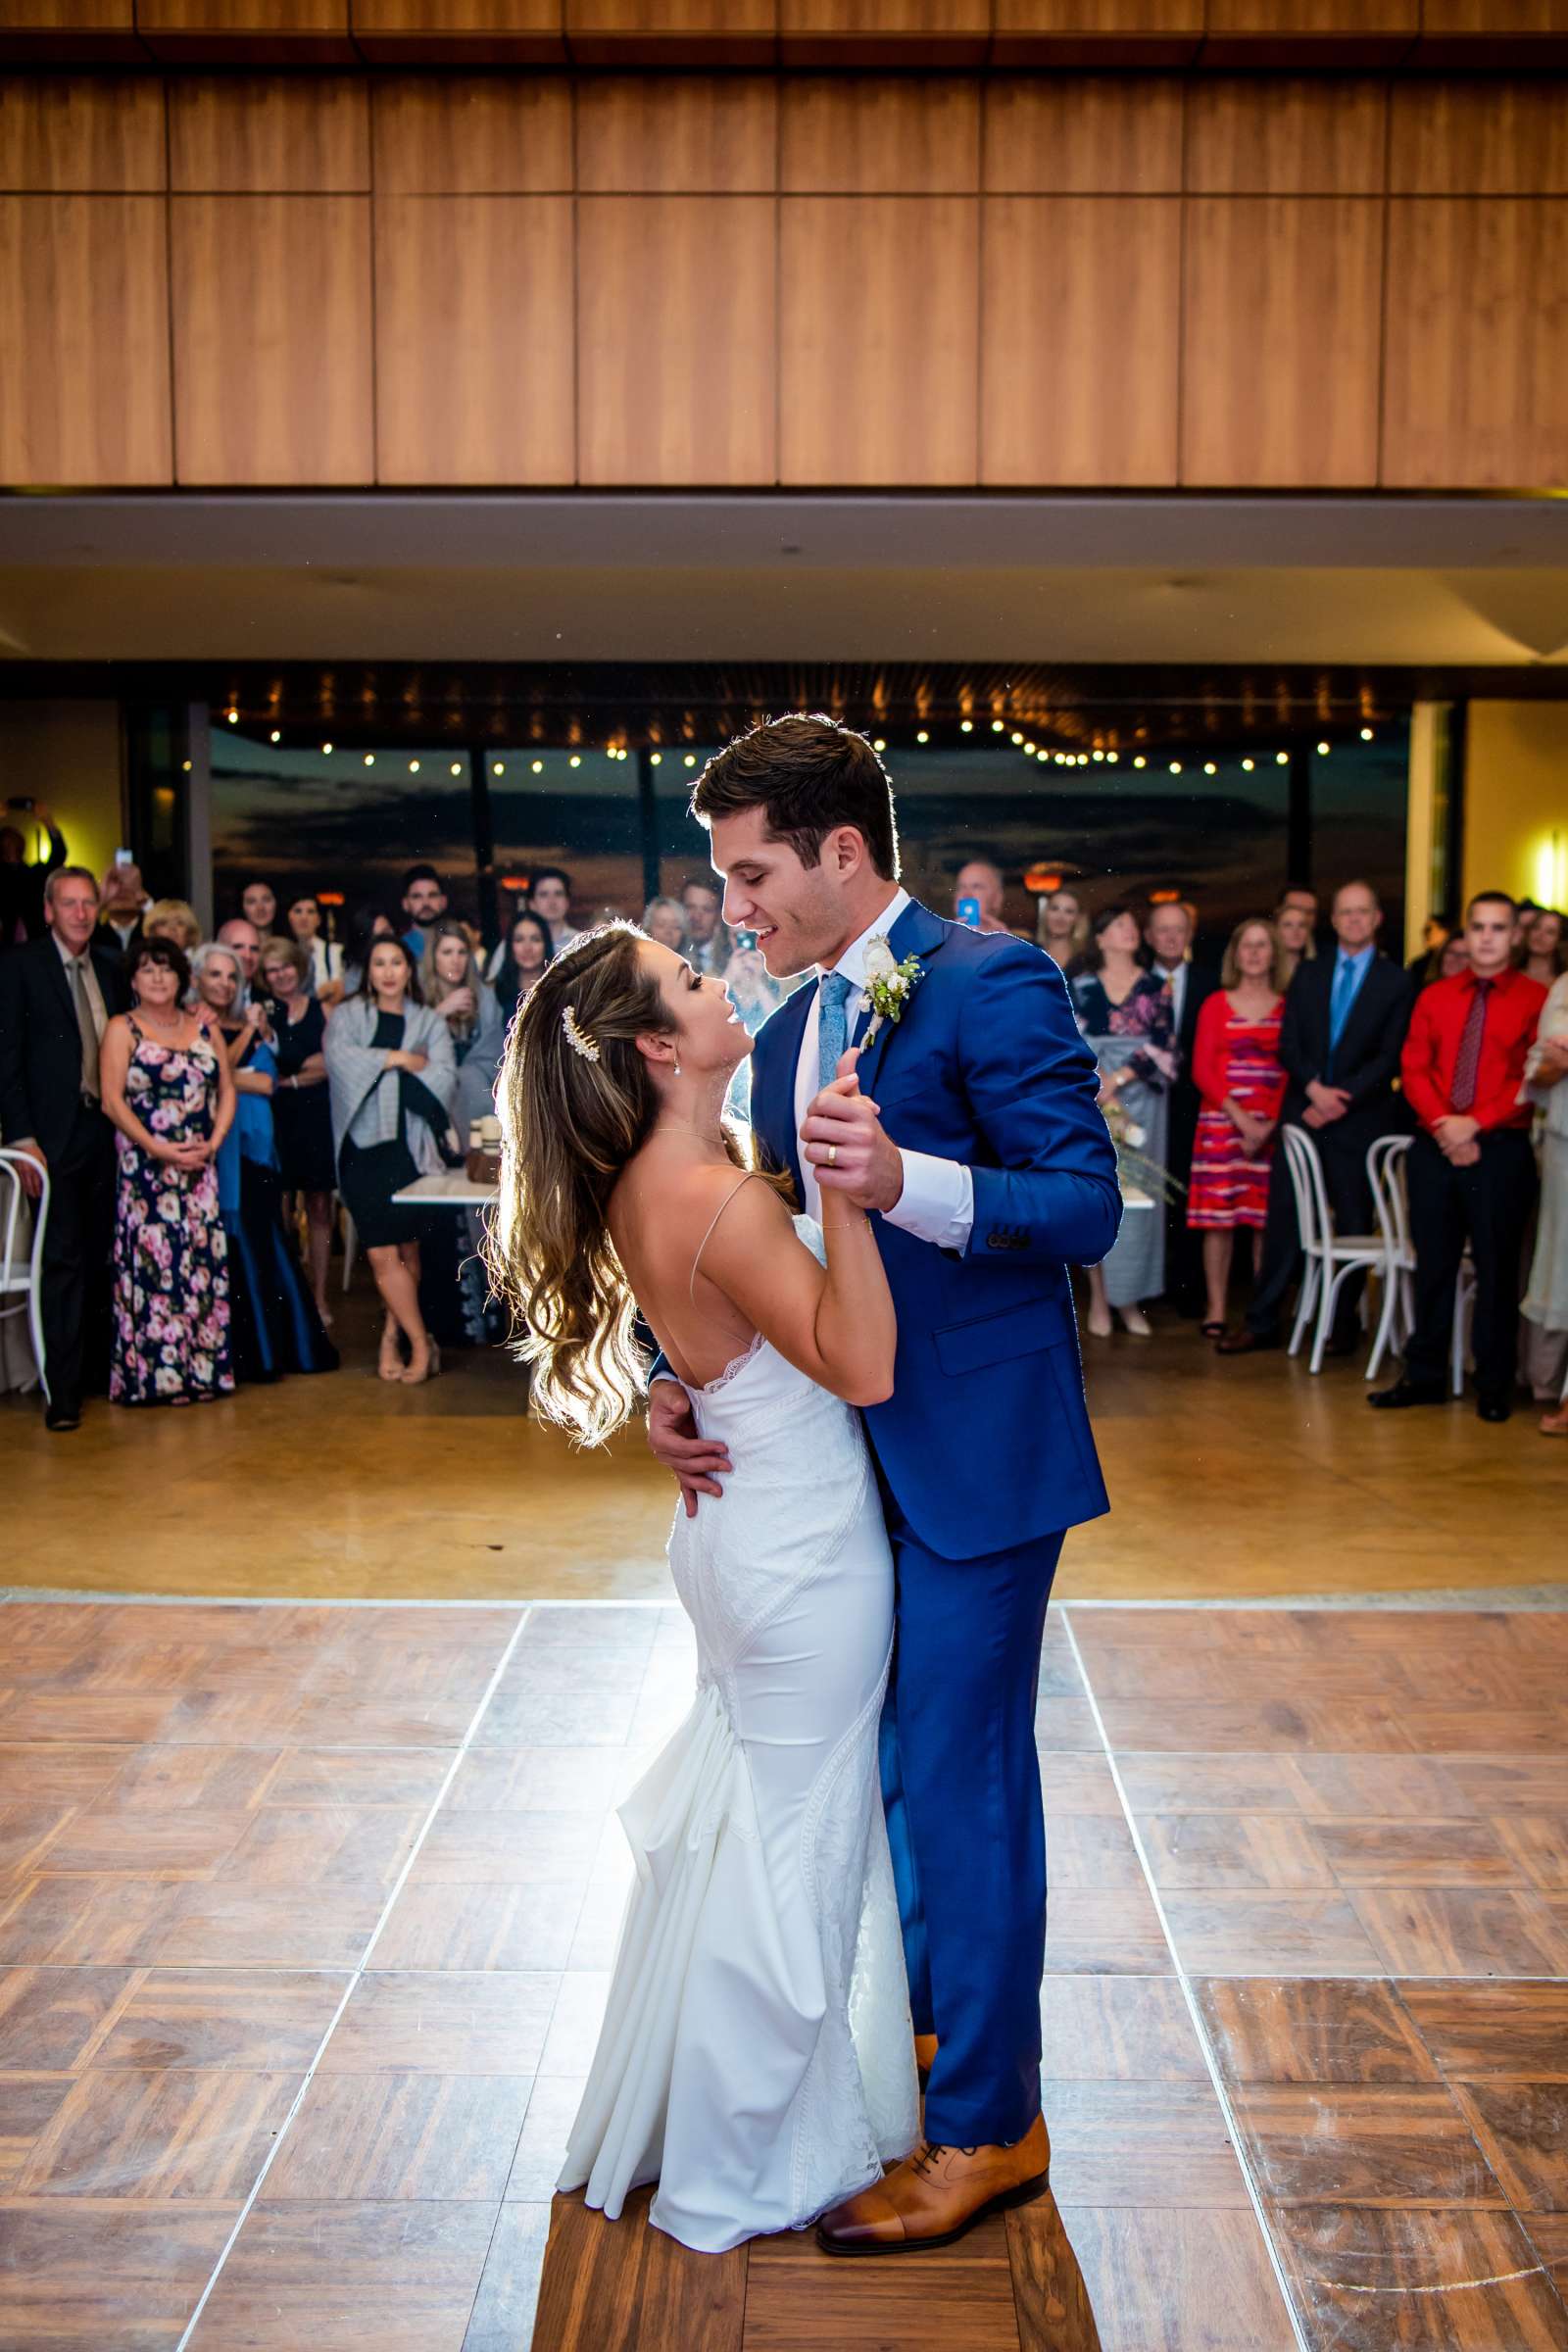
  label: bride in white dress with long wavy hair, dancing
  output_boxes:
[487,924,917,2253]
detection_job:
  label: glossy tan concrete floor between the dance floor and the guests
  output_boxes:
[0,1289,1568,1599]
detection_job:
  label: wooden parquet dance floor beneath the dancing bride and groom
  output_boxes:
[0,1580,1568,2352]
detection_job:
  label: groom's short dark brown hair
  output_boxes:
[691,712,898,882]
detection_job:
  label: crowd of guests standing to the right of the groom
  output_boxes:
[1010,868,1568,1435]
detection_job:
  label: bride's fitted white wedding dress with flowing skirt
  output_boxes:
[560,1216,919,2253]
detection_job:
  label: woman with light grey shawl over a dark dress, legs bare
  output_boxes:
[326,939,459,1383]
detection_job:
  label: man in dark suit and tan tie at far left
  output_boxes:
[0,865,124,1430]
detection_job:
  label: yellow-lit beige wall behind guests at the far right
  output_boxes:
[1464,704,1568,906]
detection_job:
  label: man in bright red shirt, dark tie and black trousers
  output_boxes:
[1368,889,1546,1421]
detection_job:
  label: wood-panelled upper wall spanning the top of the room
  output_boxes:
[0,68,1568,489]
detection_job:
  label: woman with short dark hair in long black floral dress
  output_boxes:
[101,939,235,1404]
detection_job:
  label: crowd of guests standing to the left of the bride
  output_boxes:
[0,847,761,1430]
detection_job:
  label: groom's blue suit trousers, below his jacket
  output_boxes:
[882,1498,1062,2147]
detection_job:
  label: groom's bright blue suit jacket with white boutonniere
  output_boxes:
[753,904,1121,1559]
